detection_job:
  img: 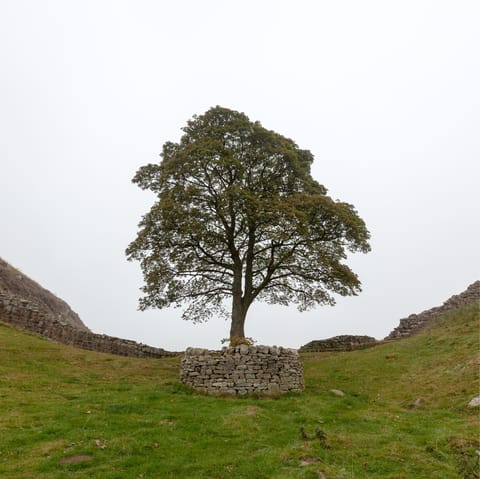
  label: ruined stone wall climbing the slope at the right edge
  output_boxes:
[385,281,480,341]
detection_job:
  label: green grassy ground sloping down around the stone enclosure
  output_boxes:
[0,305,480,479]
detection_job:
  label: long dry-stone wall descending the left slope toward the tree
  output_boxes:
[0,291,176,358]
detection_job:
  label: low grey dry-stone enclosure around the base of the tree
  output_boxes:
[180,344,304,395]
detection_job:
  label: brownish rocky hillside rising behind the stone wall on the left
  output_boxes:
[0,258,89,331]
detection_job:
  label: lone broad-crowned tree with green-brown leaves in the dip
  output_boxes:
[126,106,370,344]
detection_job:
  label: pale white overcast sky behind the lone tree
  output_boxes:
[0,0,480,350]
